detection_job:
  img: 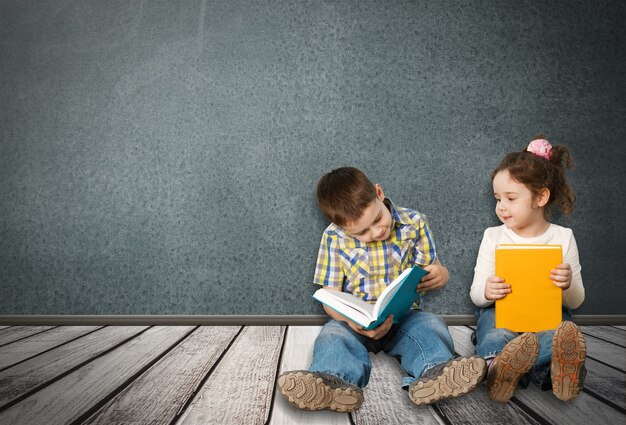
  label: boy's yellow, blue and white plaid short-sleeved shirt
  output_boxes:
[313,199,437,302]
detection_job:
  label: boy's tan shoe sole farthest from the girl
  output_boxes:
[278,370,363,412]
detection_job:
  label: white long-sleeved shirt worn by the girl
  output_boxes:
[470,223,585,309]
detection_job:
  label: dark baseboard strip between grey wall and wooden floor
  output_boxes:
[0,314,626,326]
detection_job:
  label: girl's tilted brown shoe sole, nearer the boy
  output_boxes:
[487,333,539,403]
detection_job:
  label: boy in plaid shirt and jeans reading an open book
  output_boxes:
[278,167,486,412]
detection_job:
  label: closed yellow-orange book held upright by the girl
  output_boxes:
[496,244,563,332]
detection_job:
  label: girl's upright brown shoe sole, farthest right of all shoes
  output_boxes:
[550,321,587,401]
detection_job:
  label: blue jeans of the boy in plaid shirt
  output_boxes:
[309,310,454,388]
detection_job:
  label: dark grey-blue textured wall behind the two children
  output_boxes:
[0,0,626,314]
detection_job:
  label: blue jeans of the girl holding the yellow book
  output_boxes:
[475,304,572,385]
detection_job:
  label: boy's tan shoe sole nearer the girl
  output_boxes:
[409,356,487,405]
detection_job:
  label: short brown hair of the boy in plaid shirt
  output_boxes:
[317,167,376,226]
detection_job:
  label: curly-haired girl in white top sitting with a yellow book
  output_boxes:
[470,136,586,402]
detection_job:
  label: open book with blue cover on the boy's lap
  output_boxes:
[313,266,428,330]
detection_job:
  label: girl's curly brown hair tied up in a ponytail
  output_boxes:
[491,134,576,218]
